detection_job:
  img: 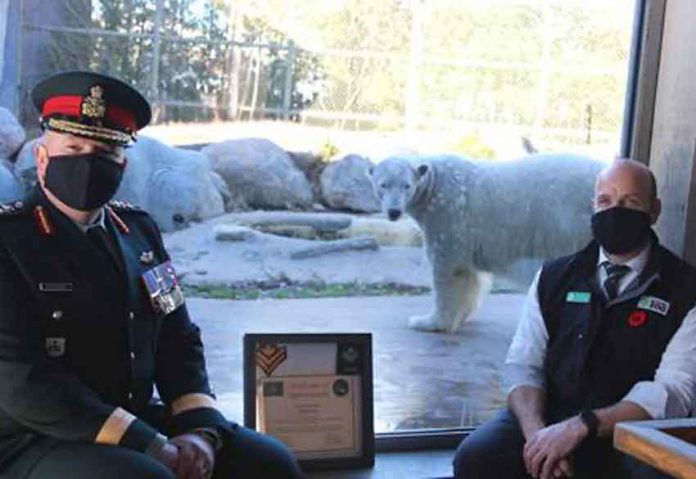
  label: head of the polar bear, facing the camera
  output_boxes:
[371,158,428,221]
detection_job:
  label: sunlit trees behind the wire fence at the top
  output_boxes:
[48,0,635,147]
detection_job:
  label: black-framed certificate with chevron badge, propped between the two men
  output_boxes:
[244,334,374,470]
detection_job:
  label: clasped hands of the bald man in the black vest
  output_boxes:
[523,417,587,479]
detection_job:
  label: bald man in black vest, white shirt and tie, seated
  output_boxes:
[454,160,696,479]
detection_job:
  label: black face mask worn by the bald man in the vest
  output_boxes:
[592,206,650,254]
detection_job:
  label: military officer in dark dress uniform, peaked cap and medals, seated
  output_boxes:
[0,72,301,479]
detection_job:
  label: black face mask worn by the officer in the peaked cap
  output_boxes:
[46,153,125,211]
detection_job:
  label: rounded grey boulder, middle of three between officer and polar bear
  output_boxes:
[202,138,314,209]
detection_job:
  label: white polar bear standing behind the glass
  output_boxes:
[371,154,604,333]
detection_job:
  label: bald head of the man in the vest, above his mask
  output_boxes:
[594,159,661,224]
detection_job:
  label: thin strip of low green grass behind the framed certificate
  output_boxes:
[183,281,430,300]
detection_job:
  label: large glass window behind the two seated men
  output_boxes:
[20,0,635,432]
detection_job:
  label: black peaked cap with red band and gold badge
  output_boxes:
[32,71,152,146]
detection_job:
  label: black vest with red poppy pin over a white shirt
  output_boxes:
[538,238,696,422]
